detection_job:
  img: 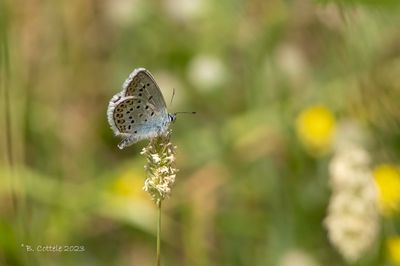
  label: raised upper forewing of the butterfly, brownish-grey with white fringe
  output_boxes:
[123,68,167,112]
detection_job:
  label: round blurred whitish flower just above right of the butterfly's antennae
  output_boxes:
[188,55,227,90]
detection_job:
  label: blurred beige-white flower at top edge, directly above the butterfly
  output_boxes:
[105,0,144,26]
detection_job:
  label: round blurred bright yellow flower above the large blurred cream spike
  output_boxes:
[296,105,336,154]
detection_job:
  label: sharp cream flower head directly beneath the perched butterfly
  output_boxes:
[141,131,178,203]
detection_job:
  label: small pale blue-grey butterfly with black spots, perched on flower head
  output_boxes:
[107,68,176,149]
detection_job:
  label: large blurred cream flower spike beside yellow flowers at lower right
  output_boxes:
[324,145,379,262]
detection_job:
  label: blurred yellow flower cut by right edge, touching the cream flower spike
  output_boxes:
[373,164,400,215]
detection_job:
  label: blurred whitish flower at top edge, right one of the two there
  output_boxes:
[164,0,206,21]
